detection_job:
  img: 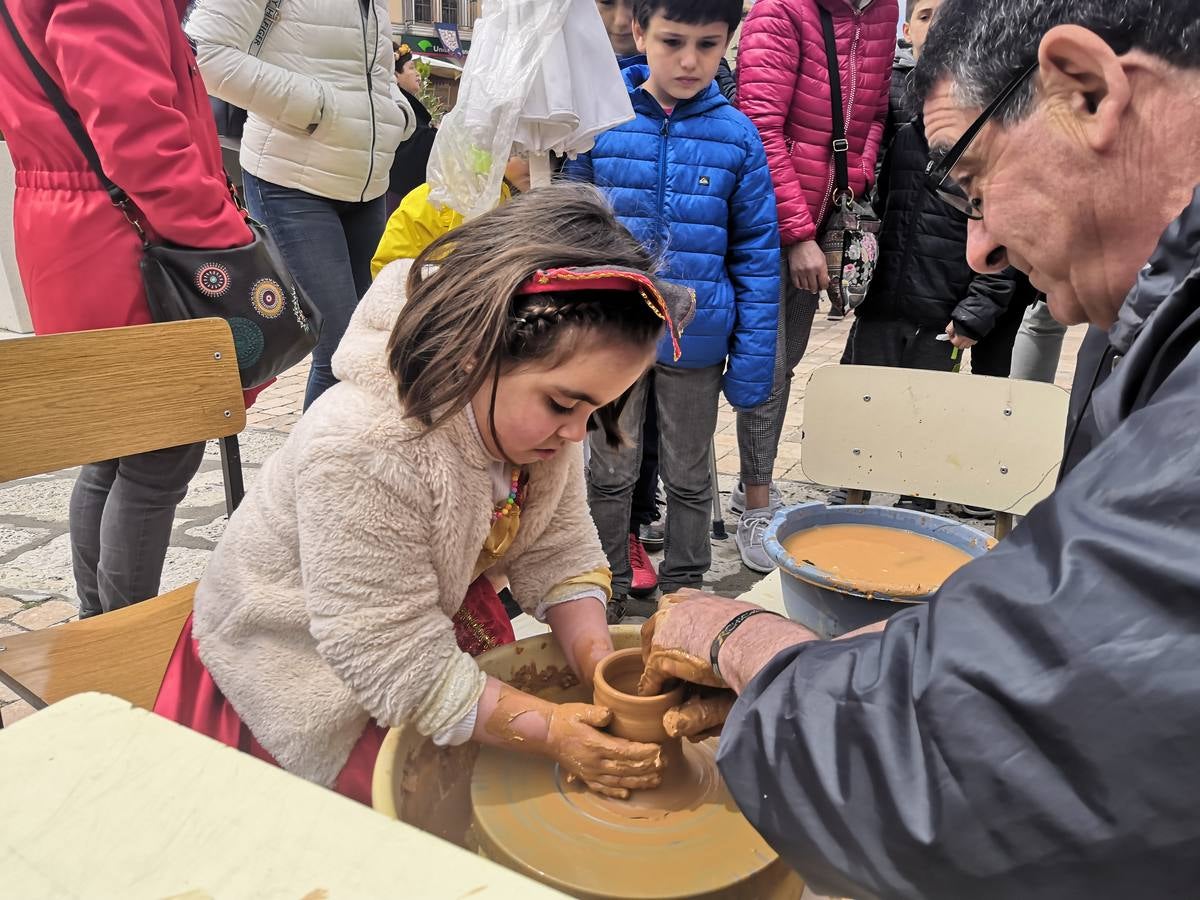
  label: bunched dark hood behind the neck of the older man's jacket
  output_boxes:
[1109,187,1200,355]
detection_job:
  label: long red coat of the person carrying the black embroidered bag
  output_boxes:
[0,0,252,335]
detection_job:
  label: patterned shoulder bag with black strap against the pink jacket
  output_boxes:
[817,7,882,319]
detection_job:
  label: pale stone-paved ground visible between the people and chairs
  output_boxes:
[0,313,1082,724]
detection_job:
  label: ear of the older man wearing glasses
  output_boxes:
[1038,25,1132,152]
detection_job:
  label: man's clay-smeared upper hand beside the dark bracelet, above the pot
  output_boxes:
[637,590,755,696]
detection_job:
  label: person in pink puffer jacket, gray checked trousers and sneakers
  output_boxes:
[732,0,899,571]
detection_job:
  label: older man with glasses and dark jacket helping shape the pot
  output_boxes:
[644,0,1200,900]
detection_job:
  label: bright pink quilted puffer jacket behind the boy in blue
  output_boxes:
[738,0,899,246]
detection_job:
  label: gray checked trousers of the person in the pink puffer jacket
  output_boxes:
[738,252,818,485]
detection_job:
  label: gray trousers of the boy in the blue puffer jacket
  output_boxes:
[588,364,725,596]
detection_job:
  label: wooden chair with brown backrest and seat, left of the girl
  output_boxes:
[0,319,246,724]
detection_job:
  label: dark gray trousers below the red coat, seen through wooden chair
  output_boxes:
[71,442,204,619]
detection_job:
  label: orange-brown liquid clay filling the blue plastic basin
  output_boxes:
[784,524,971,596]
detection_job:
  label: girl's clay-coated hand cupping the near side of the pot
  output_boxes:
[546,703,662,799]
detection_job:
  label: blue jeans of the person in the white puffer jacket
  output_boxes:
[242,172,388,409]
